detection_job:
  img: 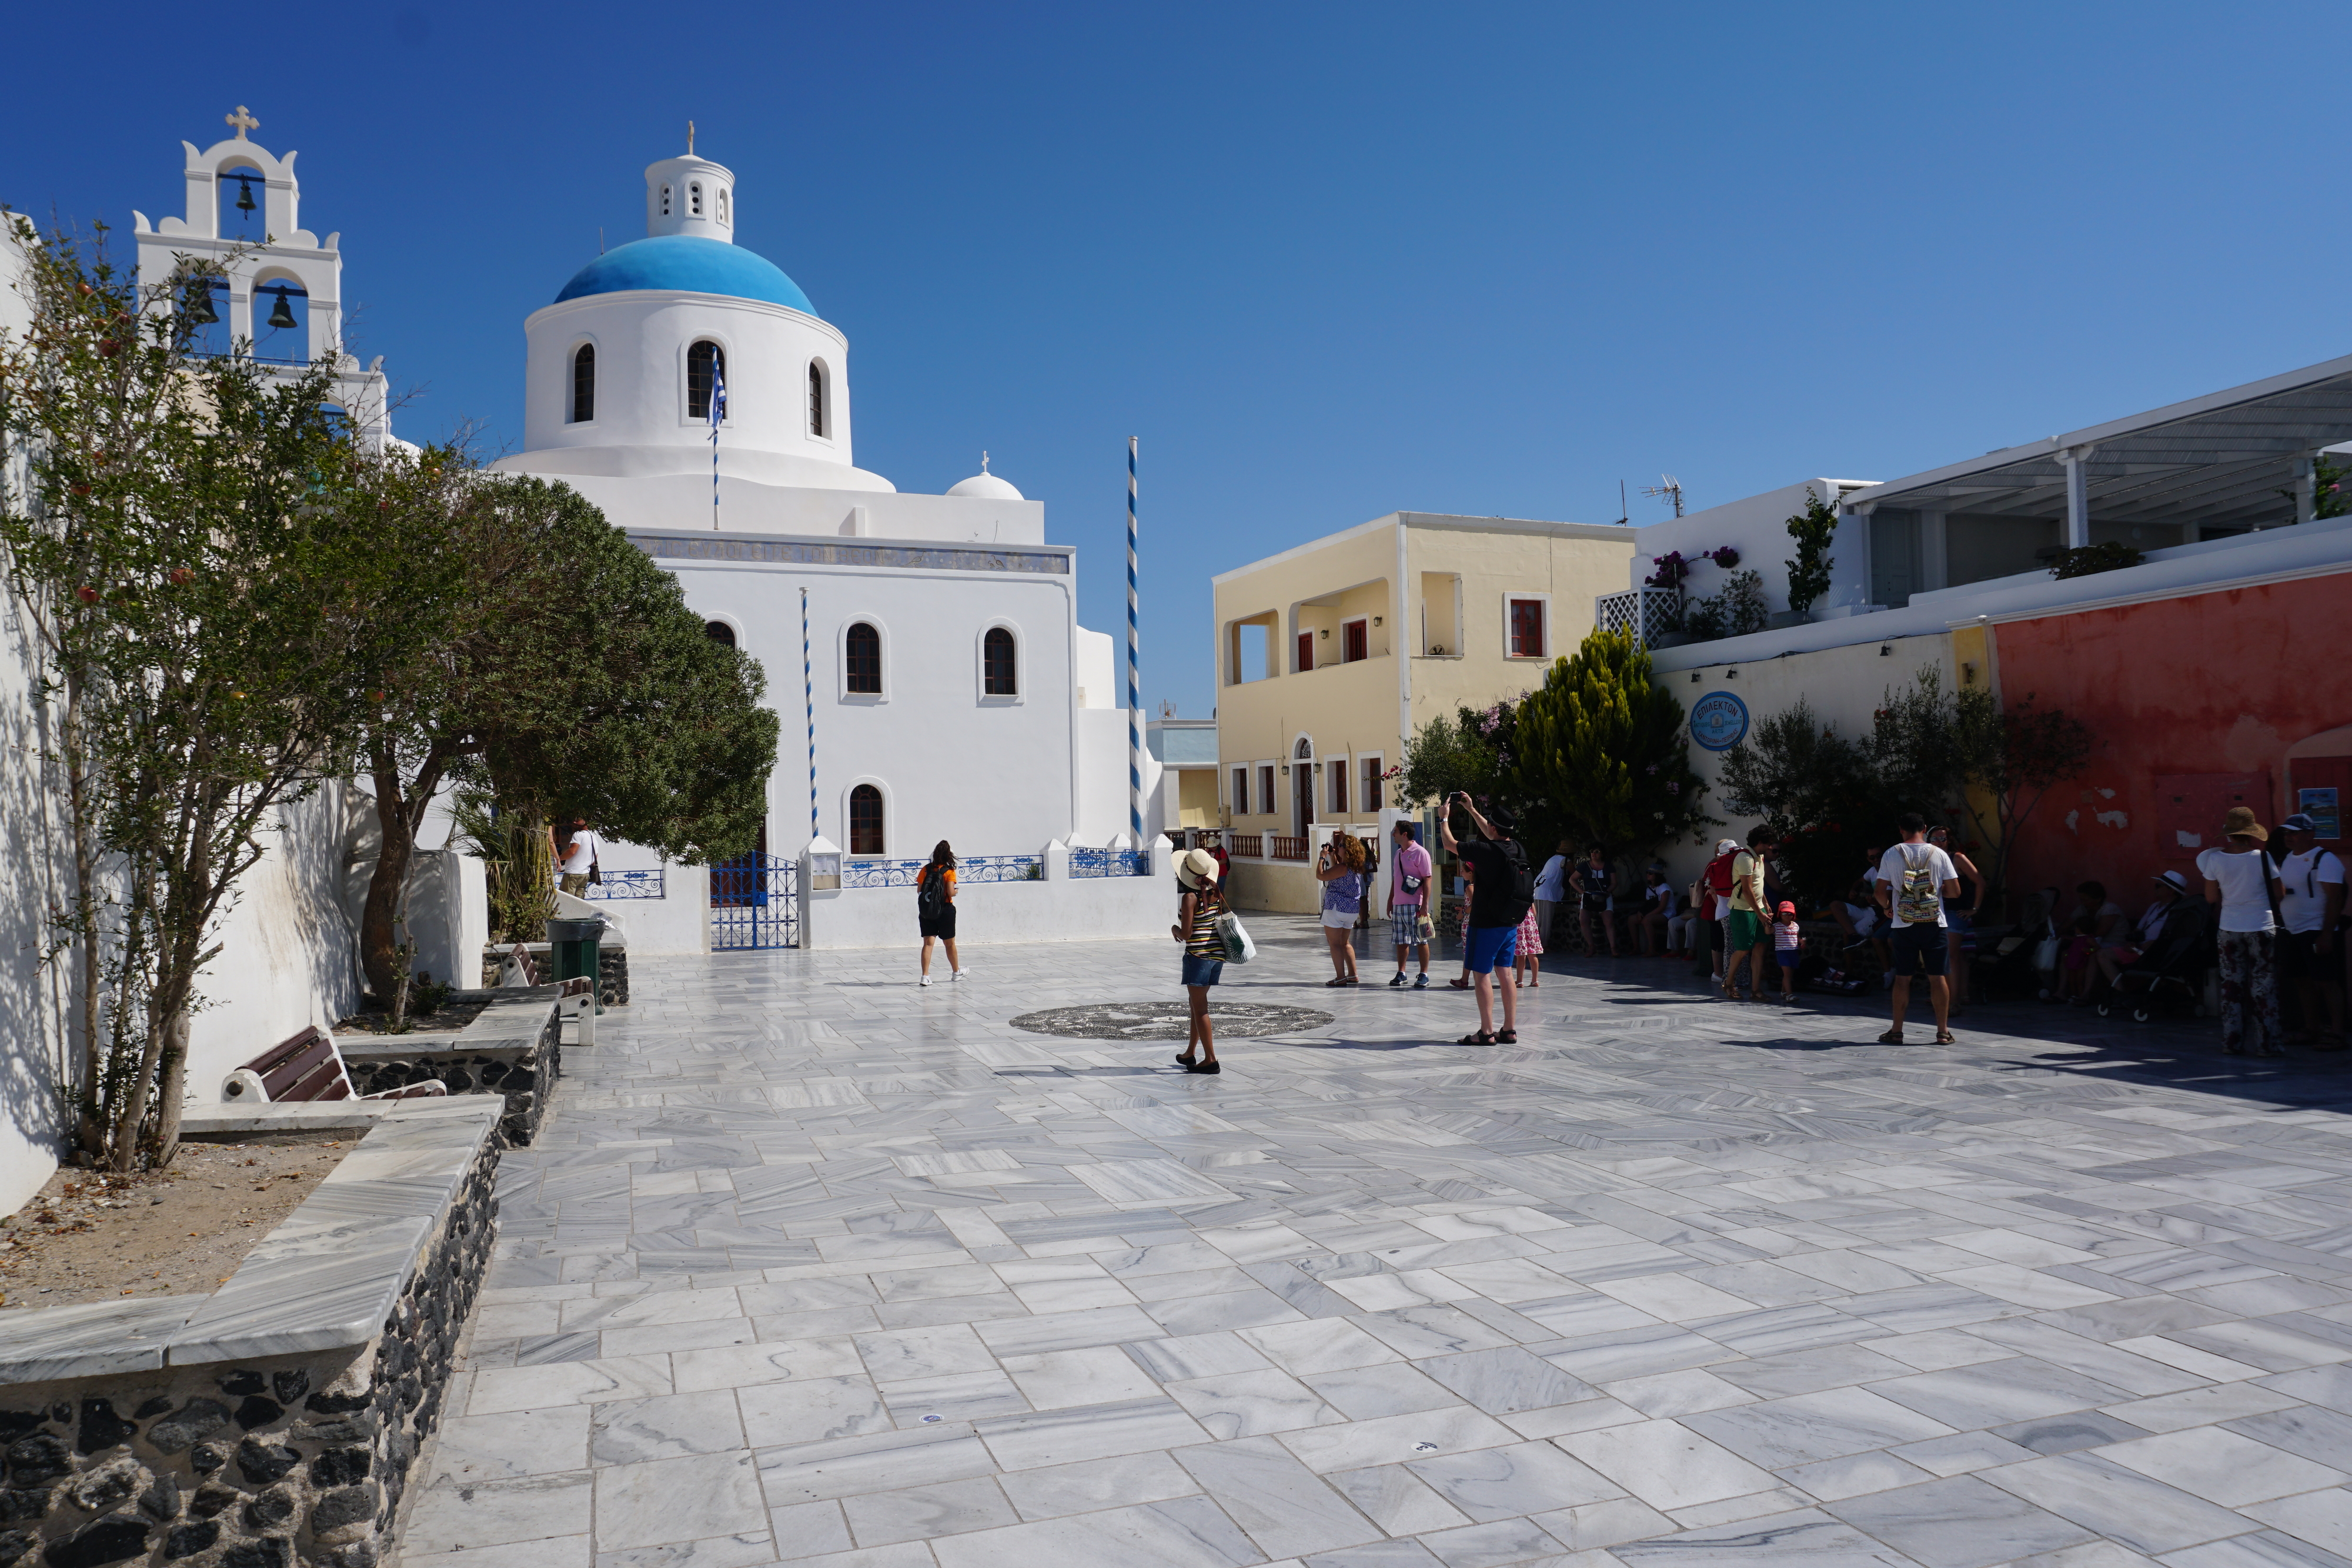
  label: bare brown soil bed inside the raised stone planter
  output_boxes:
[0,1133,358,1309]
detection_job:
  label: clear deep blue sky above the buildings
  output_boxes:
[0,0,2352,717]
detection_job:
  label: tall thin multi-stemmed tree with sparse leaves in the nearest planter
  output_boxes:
[0,219,388,1171]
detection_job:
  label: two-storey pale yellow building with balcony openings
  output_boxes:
[1216,513,1632,912]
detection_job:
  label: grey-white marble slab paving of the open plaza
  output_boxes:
[402,914,2352,1568]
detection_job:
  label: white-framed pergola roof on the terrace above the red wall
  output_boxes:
[1842,355,2352,548]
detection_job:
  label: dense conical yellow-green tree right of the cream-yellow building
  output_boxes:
[1505,630,1717,858]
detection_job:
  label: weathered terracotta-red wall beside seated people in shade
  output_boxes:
[1994,569,2352,910]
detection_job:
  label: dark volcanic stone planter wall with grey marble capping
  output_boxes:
[0,1100,499,1568]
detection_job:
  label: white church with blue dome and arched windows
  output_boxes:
[496,151,1169,947]
